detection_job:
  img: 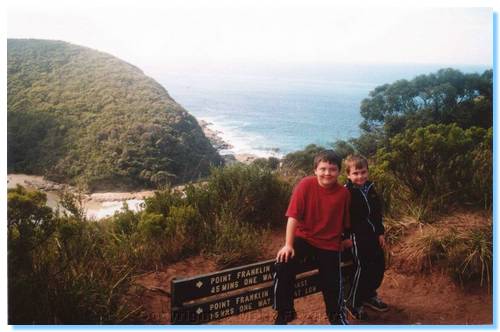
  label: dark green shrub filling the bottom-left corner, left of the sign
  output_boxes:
[8,187,141,324]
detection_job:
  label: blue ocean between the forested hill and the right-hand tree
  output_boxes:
[152,64,488,157]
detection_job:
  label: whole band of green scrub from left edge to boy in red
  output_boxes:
[8,165,291,324]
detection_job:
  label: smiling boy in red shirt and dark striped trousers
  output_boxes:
[273,150,350,325]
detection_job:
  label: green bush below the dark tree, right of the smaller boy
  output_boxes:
[377,124,492,211]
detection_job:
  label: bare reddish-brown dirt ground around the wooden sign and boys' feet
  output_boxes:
[132,232,493,325]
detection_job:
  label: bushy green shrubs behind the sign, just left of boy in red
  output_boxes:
[108,164,291,269]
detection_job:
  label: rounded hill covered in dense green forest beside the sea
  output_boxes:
[7,39,221,190]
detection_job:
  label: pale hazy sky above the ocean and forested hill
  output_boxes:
[7,0,493,68]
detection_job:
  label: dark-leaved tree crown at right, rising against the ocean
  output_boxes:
[360,68,493,143]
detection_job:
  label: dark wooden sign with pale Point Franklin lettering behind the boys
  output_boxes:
[171,259,351,325]
